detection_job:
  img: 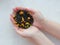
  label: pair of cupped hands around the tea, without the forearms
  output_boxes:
[10,7,44,37]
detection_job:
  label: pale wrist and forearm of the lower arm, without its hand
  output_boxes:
[32,32,54,45]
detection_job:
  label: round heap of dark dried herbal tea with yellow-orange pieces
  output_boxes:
[14,10,34,29]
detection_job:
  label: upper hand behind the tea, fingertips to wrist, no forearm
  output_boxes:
[12,7,45,29]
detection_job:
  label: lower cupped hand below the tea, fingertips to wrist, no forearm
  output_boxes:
[10,15,39,38]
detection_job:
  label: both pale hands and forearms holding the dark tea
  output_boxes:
[10,7,60,45]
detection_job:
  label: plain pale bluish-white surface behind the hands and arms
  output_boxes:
[0,0,60,45]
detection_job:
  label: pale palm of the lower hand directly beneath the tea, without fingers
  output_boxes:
[16,26,38,37]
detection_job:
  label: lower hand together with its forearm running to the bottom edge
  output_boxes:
[10,15,54,45]
